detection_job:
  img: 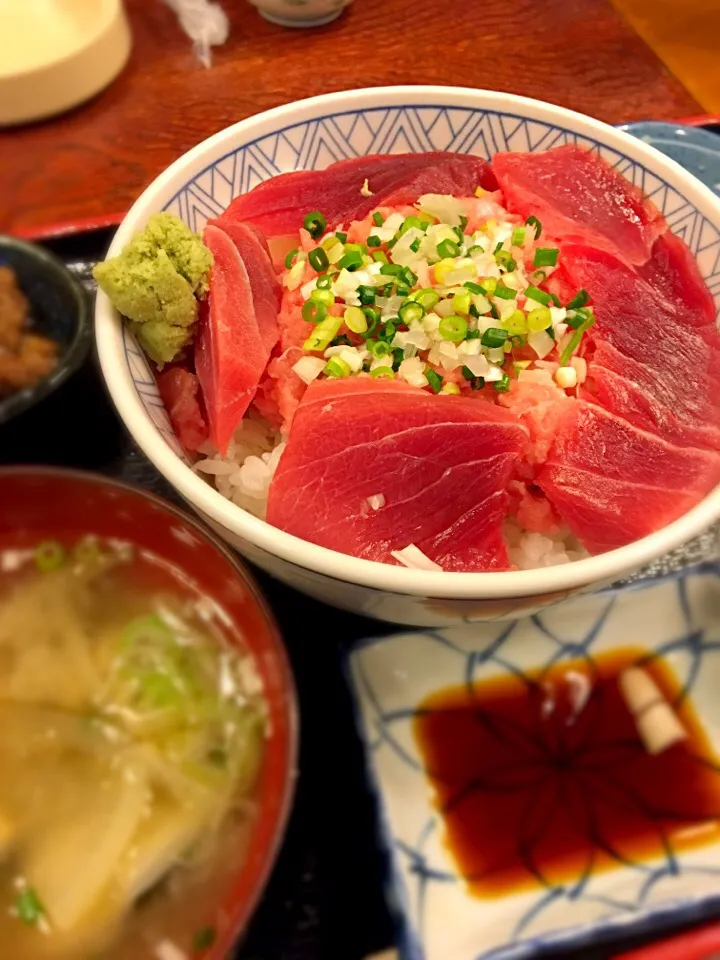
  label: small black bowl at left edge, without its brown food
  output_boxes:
[0,236,92,425]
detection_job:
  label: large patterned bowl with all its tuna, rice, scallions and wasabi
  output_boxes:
[96,87,720,625]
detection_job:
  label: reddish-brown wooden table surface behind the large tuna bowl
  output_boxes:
[0,0,702,232]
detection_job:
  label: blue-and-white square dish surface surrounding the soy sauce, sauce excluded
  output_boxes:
[349,564,720,960]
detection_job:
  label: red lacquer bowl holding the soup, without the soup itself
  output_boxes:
[0,467,298,960]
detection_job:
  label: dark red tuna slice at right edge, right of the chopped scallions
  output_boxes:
[562,244,720,450]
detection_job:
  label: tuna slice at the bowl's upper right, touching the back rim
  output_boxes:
[492,146,667,263]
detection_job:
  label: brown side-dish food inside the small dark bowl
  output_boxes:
[0,266,58,398]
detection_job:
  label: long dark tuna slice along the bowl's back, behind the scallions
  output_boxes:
[221,153,497,237]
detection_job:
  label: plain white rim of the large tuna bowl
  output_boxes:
[95,86,720,599]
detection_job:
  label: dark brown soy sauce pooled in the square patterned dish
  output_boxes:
[414,649,720,897]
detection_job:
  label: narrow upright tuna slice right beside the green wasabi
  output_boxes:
[195,225,277,453]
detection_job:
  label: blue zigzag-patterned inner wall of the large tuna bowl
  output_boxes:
[125,103,720,452]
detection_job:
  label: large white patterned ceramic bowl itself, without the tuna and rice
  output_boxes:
[96,86,720,626]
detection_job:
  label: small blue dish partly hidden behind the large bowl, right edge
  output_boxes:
[620,120,720,197]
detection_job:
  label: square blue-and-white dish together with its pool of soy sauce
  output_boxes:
[349,563,720,960]
